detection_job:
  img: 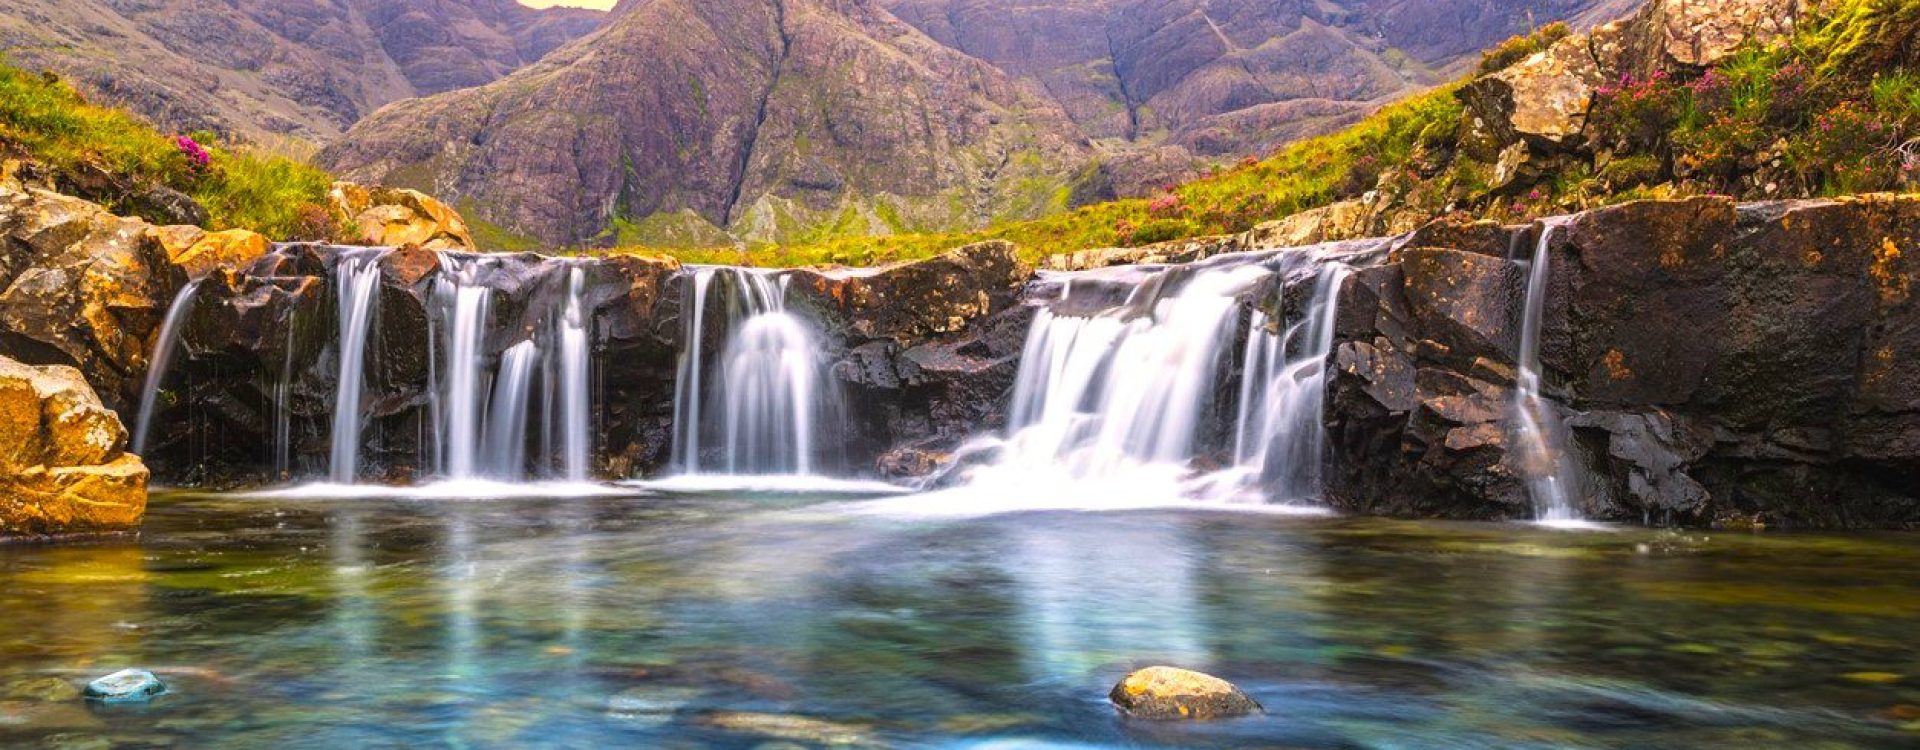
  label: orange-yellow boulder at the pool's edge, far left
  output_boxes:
[0,357,148,537]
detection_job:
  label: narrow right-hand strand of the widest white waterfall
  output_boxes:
[1235,263,1352,499]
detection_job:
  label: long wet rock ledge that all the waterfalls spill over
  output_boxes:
[0,167,1920,527]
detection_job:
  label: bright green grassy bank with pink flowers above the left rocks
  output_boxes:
[0,63,332,240]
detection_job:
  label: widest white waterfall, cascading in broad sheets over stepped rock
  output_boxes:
[936,242,1386,512]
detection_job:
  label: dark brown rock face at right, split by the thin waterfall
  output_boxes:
[1327,196,1920,527]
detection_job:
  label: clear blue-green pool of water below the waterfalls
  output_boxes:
[0,493,1920,748]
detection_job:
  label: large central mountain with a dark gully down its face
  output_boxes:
[319,0,1089,247]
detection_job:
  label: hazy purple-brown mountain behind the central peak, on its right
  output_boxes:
[883,0,1638,155]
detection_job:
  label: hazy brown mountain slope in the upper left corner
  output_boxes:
[0,0,607,140]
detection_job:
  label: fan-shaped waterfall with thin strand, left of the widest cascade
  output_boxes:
[674,269,839,476]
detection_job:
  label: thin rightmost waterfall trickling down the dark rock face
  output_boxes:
[1511,217,1580,524]
